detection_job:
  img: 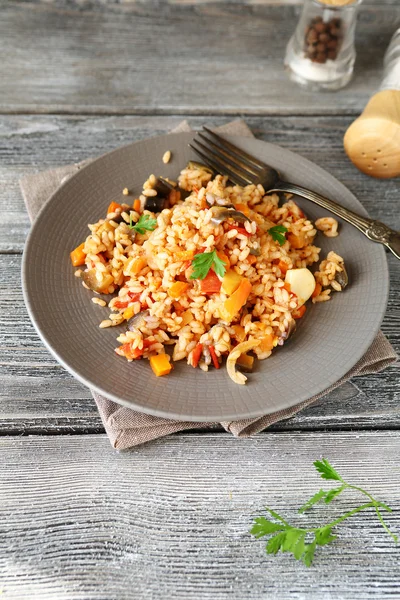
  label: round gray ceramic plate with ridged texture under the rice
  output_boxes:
[22,133,388,421]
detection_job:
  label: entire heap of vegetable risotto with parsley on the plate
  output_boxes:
[71,163,347,384]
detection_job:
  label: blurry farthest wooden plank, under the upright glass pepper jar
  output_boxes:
[0,0,400,114]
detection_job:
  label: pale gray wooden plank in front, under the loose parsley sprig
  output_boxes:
[0,431,400,600]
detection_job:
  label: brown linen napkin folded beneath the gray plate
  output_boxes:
[20,120,397,450]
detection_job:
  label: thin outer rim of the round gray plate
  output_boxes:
[21,131,390,423]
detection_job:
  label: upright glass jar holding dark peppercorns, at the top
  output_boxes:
[285,0,362,91]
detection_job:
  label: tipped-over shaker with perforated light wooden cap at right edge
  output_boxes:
[344,28,400,179]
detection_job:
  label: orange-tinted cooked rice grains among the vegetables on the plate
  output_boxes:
[75,167,343,383]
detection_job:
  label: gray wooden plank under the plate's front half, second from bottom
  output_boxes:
[0,255,400,434]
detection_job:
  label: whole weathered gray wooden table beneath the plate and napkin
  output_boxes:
[0,0,400,600]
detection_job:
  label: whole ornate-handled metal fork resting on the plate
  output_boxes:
[189,127,400,259]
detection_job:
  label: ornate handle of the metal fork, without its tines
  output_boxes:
[268,181,400,260]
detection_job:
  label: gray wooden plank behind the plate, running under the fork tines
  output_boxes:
[0,115,400,252]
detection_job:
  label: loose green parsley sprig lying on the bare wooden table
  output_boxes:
[250,458,398,567]
